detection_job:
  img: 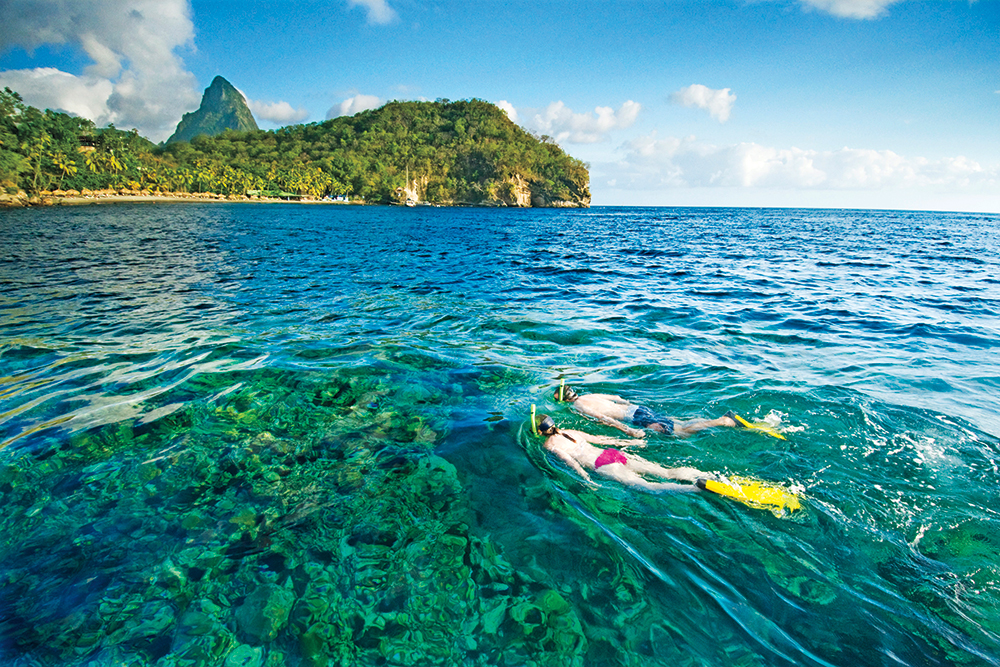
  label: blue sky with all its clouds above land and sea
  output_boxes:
[0,0,1000,212]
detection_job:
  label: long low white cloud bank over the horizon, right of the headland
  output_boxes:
[601,133,1000,192]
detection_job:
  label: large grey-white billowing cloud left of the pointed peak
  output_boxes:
[0,0,200,141]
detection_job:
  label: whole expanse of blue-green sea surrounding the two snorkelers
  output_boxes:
[0,204,1000,665]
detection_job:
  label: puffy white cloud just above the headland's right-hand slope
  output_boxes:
[508,100,642,144]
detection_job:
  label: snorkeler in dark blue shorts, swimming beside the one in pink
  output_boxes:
[555,386,738,438]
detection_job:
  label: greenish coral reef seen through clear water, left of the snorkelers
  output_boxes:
[0,352,608,666]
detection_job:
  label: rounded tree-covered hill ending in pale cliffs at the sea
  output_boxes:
[162,100,590,206]
